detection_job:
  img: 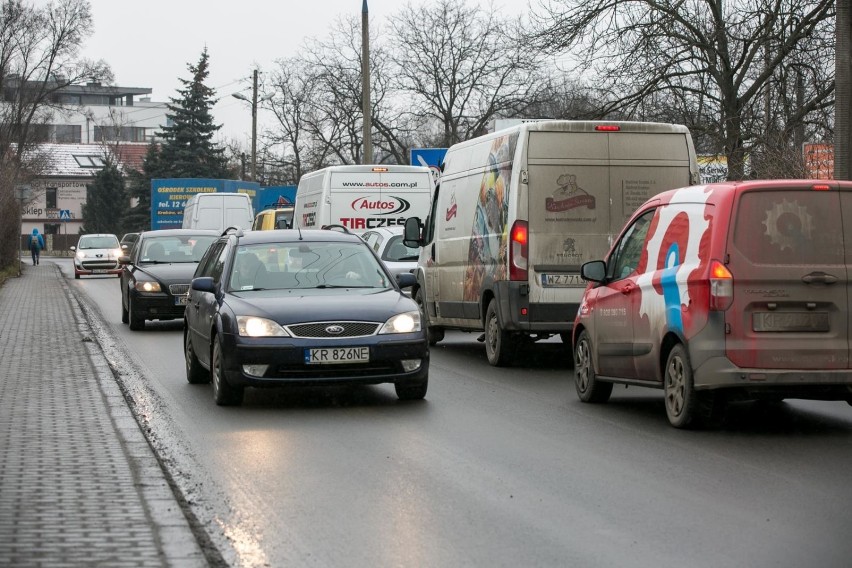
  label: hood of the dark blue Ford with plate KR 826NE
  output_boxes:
[227,288,418,325]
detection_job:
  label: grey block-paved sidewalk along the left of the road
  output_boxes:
[0,260,208,567]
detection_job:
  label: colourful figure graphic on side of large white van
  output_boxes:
[466,133,518,301]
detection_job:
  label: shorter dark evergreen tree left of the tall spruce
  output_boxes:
[80,156,127,236]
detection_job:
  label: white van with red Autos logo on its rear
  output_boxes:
[293,165,435,233]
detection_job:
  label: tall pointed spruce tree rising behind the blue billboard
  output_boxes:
[159,48,231,179]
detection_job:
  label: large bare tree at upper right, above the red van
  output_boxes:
[531,0,835,178]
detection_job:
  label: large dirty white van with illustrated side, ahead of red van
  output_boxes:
[405,121,699,365]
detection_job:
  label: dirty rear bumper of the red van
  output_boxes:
[693,356,852,400]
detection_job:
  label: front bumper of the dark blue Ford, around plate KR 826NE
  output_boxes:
[223,334,429,387]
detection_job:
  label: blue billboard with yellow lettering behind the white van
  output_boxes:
[151,178,260,230]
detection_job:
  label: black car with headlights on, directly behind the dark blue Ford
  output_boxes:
[118,229,220,331]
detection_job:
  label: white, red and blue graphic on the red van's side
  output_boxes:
[636,186,711,335]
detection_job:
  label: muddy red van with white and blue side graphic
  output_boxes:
[572,180,852,428]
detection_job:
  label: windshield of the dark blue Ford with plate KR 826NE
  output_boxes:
[229,241,391,291]
